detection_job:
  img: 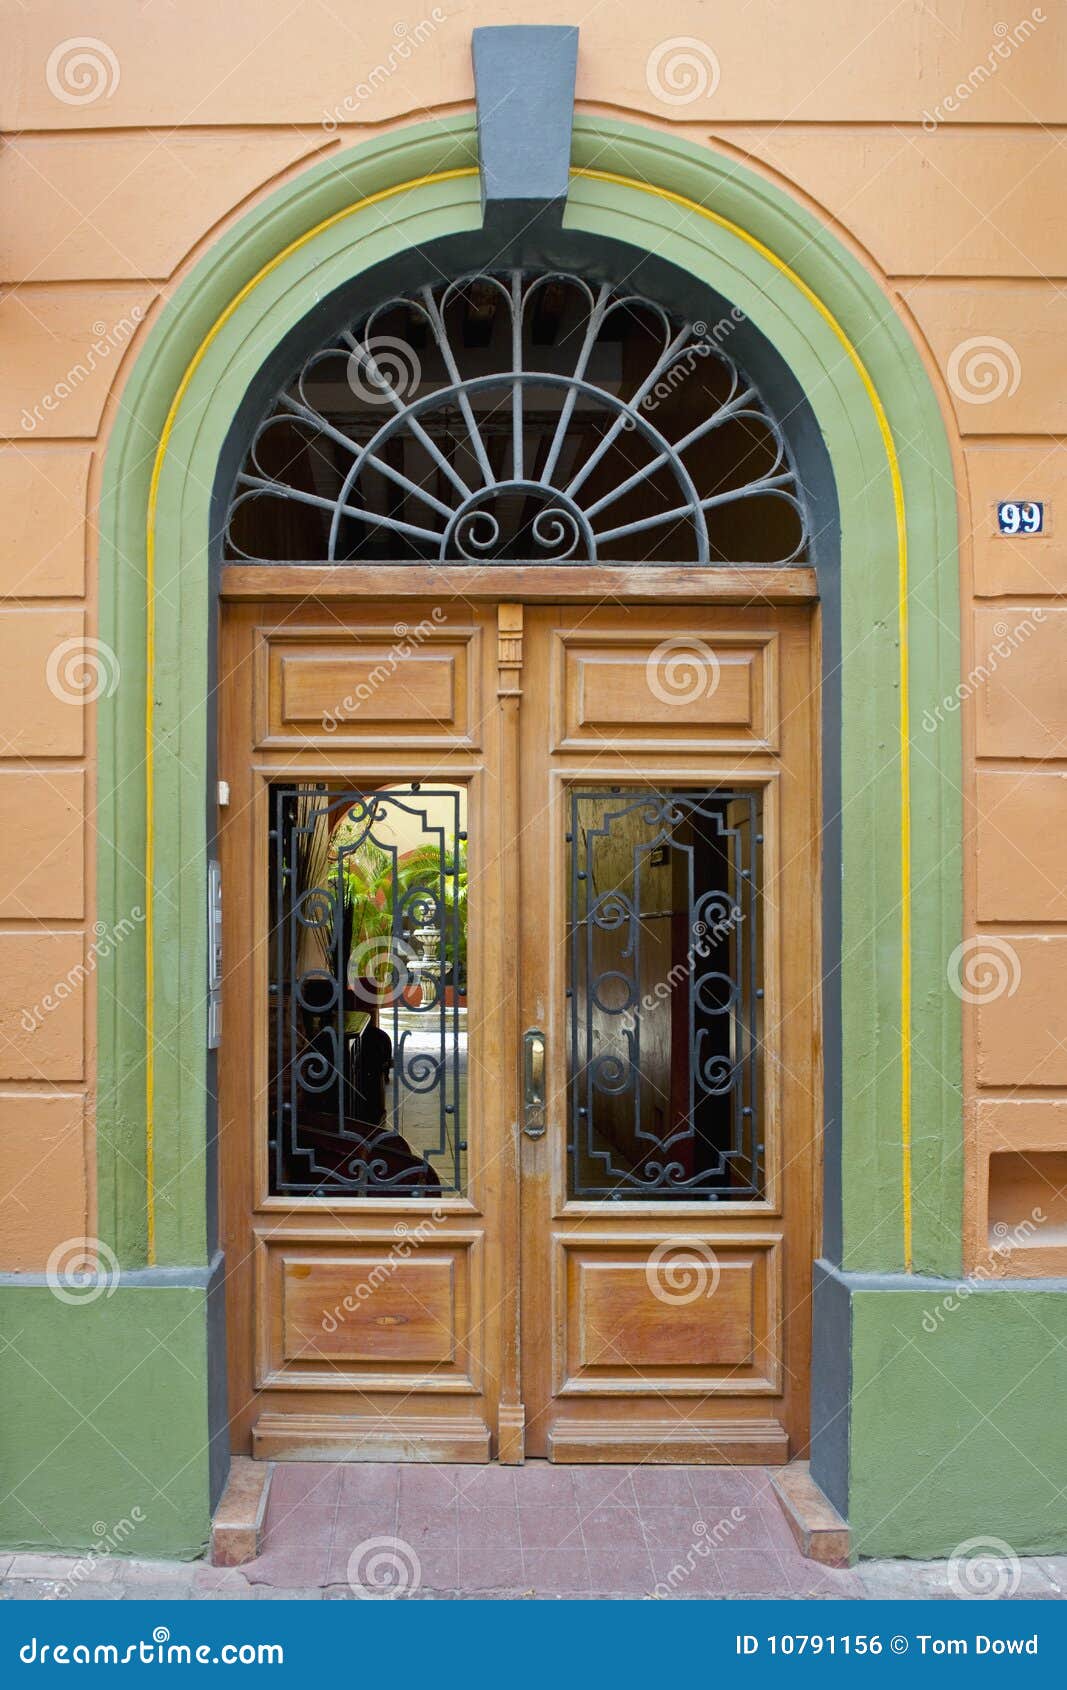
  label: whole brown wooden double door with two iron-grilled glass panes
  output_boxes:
[218,583,820,1462]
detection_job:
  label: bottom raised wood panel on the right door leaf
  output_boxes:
[556,1232,780,1396]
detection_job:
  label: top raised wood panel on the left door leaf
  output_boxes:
[255,624,477,749]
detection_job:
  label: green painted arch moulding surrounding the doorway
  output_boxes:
[98,117,962,1274]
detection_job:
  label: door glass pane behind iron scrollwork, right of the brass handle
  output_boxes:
[566,788,764,1202]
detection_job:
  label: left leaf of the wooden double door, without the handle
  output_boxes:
[220,603,517,1462]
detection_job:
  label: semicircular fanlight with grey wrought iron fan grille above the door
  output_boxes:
[227,269,807,564]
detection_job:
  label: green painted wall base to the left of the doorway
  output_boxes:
[0,1274,211,1560]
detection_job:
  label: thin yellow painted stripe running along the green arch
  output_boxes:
[145,166,911,1271]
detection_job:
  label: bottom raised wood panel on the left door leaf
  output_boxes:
[255,1232,480,1391]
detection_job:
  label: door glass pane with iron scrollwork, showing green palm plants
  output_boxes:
[269,781,467,1197]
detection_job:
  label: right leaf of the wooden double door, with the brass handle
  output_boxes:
[523,607,820,1462]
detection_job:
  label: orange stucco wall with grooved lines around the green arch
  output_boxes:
[0,0,1067,1273]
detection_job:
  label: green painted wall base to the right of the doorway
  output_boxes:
[849,1276,1067,1560]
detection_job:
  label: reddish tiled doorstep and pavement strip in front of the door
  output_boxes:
[0,1462,1067,1600]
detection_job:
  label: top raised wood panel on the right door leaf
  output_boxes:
[556,629,778,750]
